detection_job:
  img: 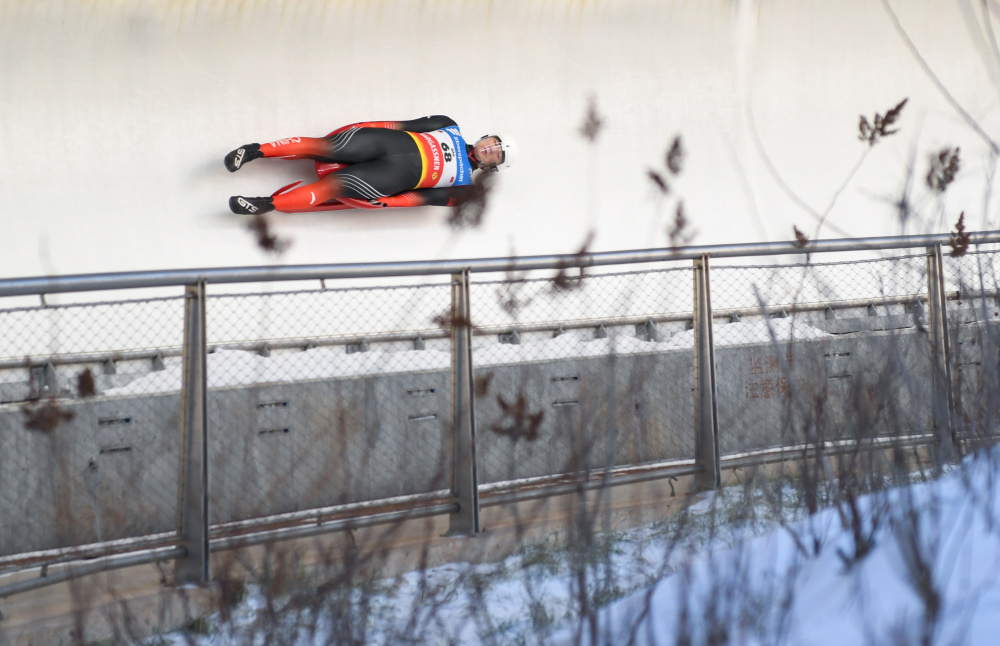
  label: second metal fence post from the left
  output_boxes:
[448,270,479,536]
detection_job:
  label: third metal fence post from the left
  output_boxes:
[694,254,722,491]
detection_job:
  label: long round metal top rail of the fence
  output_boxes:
[0,231,1000,297]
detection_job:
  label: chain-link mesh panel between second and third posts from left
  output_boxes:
[470,268,694,484]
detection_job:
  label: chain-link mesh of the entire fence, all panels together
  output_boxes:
[0,235,1000,580]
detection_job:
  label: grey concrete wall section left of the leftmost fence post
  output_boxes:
[0,394,180,555]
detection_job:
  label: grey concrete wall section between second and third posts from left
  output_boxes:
[476,351,694,484]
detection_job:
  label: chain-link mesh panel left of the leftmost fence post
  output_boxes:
[0,298,184,556]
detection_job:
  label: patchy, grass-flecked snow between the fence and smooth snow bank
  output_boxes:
[151,489,795,646]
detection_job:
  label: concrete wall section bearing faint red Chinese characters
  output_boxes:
[716,329,933,455]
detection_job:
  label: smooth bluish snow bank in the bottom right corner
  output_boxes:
[553,451,1000,646]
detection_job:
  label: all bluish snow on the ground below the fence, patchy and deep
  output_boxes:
[148,451,1000,646]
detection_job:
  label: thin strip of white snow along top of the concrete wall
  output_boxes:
[104,318,830,396]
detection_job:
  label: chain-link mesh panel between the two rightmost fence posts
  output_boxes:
[712,255,932,454]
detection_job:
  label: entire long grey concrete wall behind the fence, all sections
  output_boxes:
[0,322,998,555]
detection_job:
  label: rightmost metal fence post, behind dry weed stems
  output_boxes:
[927,244,955,463]
